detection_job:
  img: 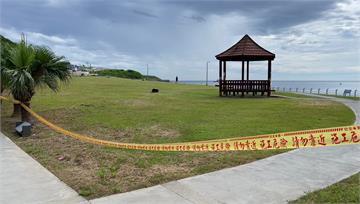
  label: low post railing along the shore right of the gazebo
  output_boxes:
[272,87,360,97]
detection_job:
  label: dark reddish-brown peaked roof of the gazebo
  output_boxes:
[215,34,275,61]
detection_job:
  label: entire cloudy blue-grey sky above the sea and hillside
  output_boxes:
[0,0,360,80]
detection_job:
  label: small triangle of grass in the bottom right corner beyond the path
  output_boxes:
[289,173,360,204]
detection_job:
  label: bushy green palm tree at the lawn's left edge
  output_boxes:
[5,35,70,121]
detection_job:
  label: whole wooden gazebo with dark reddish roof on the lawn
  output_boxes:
[216,35,275,96]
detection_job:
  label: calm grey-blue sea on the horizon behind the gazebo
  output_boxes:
[178,80,360,95]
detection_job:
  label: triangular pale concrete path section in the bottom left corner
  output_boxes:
[0,132,88,204]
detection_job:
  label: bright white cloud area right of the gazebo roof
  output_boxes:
[252,1,360,75]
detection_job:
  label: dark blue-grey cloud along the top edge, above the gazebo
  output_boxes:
[168,0,337,34]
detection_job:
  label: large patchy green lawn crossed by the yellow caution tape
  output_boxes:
[1,77,355,198]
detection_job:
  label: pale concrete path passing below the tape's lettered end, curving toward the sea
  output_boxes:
[90,96,360,204]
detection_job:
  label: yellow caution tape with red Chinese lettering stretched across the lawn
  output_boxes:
[0,96,360,151]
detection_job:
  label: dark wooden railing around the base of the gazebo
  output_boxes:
[219,80,270,95]
